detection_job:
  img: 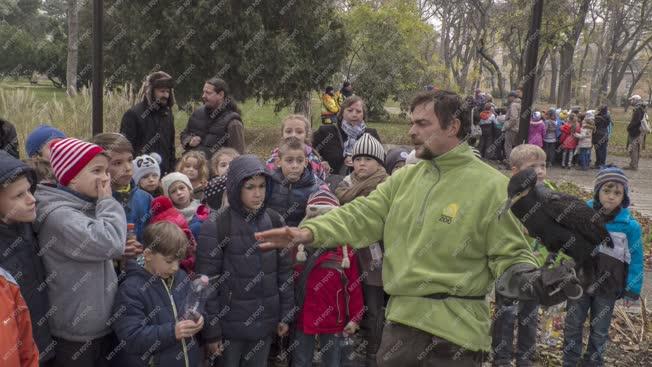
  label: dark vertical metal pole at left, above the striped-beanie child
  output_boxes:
[92,0,104,135]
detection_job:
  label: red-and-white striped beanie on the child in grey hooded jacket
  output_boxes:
[50,138,104,186]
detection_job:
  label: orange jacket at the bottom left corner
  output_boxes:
[0,268,38,367]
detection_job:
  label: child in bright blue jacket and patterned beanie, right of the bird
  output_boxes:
[563,167,644,367]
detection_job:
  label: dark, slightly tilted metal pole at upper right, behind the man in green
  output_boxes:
[517,0,543,145]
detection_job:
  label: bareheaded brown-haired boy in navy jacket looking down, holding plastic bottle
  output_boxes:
[111,221,204,367]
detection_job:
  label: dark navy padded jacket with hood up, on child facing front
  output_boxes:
[195,155,296,342]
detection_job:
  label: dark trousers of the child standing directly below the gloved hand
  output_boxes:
[491,293,539,366]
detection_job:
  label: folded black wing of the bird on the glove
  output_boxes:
[542,192,611,246]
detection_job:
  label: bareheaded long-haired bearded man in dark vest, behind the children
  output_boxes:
[181,78,245,160]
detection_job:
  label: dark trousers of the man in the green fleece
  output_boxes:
[377,322,485,367]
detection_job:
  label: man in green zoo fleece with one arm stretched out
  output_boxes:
[257,91,574,367]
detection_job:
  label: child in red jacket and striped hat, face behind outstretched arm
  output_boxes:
[292,190,364,367]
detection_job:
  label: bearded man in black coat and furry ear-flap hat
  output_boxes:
[120,71,176,176]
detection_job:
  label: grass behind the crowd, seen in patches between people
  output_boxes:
[0,80,652,157]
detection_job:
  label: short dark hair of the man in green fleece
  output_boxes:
[410,90,473,140]
